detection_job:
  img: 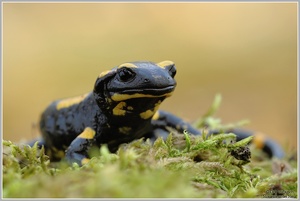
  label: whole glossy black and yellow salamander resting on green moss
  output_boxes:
[29,61,284,165]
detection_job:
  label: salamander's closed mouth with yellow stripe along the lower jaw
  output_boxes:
[110,86,175,101]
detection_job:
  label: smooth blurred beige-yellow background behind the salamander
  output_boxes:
[3,3,297,151]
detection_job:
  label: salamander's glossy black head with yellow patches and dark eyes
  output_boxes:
[94,61,176,119]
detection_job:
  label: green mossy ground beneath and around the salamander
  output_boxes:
[2,96,298,198]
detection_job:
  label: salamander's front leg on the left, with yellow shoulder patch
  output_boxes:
[66,127,96,165]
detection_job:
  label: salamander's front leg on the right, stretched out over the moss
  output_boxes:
[151,110,201,138]
